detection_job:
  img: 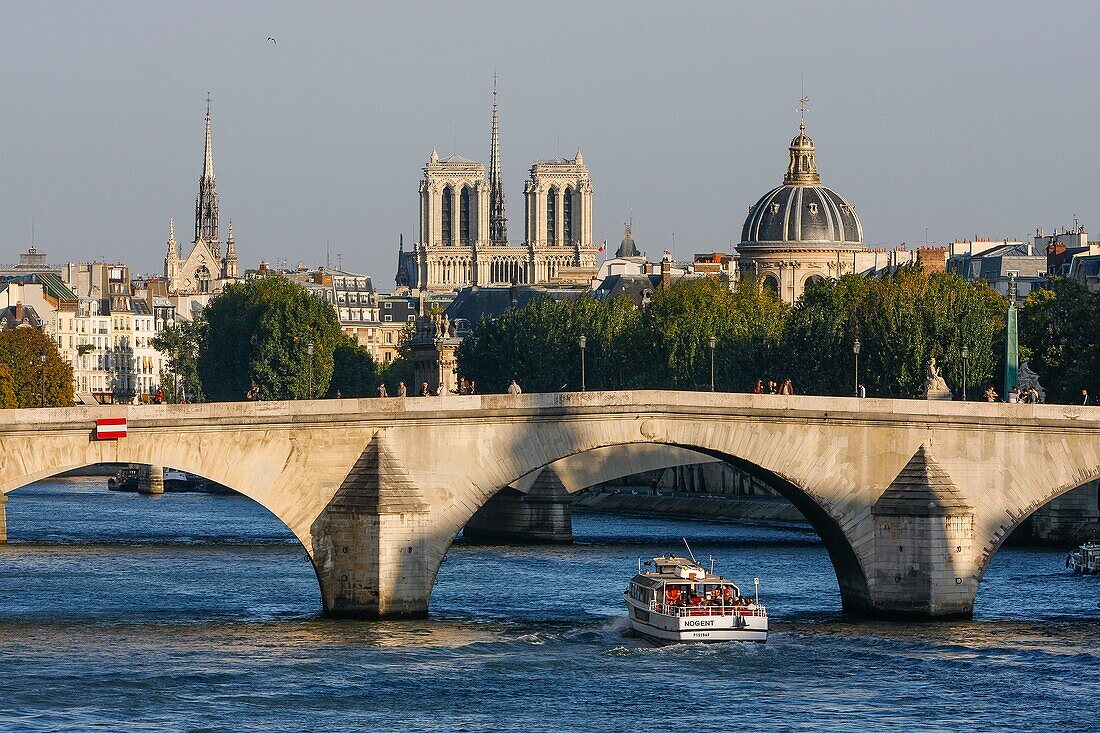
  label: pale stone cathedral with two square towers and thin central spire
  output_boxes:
[397,85,596,292]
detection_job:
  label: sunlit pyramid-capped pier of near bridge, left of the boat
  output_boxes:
[311,431,439,619]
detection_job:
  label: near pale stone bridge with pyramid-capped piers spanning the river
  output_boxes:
[0,391,1100,617]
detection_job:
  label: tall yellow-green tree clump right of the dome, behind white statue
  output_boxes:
[783,266,1008,397]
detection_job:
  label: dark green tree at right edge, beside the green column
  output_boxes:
[1019,277,1100,403]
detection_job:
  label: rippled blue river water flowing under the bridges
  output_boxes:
[0,479,1100,733]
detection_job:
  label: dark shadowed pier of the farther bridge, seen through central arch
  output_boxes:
[462,467,573,545]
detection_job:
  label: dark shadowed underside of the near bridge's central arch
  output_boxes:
[432,439,870,610]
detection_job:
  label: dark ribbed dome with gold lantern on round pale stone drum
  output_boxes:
[737,122,865,304]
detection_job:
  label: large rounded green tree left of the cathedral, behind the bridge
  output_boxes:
[198,277,341,401]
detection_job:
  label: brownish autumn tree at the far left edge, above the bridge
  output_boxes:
[0,328,74,407]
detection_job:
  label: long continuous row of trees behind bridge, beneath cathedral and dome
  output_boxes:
[459,266,1008,397]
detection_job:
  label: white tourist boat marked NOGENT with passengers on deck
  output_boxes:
[624,543,768,642]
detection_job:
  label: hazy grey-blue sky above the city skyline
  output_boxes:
[0,0,1100,279]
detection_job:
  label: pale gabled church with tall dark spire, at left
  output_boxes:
[164,99,240,294]
